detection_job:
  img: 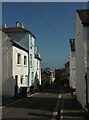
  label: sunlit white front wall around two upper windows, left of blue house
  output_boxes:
[13,46,28,92]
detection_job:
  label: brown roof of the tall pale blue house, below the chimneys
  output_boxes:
[2,27,36,39]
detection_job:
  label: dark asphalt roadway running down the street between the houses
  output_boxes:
[2,84,60,120]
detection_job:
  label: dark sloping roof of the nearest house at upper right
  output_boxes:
[76,9,89,26]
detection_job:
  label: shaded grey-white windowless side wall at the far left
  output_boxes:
[2,33,14,97]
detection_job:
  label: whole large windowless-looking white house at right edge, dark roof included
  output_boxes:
[75,10,89,108]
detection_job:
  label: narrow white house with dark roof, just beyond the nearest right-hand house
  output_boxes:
[69,39,76,92]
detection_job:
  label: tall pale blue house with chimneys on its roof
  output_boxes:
[3,22,36,90]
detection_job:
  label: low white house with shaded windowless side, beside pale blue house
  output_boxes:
[2,32,28,97]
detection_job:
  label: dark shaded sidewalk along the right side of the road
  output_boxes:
[60,88,89,120]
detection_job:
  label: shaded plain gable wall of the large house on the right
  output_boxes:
[75,13,86,108]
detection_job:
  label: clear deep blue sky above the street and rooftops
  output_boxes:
[2,2,87,71]
